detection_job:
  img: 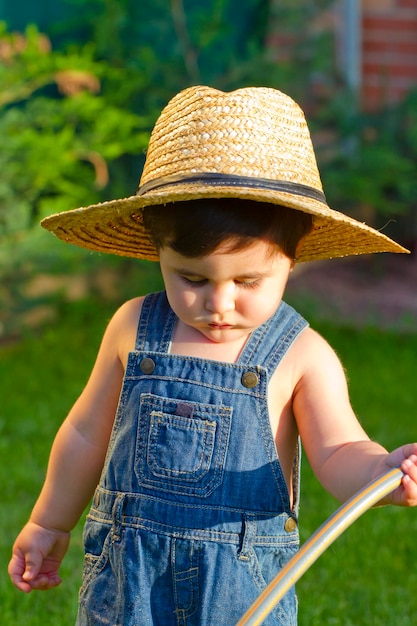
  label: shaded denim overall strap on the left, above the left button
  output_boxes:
[135,291,177,353]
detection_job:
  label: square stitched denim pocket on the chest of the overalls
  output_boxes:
[135,394,232,497]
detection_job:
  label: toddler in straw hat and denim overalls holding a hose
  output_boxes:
[9,86,417,626]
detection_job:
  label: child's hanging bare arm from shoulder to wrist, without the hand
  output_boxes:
[30,300,131,531]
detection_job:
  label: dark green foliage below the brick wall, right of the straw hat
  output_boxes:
[316,91,417,240]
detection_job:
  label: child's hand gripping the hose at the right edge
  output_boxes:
[378,443,417,506]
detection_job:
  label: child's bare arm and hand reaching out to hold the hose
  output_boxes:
[293,330,417,506]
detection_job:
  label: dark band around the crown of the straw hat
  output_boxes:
[136,172,327,206]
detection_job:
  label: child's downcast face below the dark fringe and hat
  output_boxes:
[159,240,293,343]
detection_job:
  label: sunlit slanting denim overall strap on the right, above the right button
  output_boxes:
[238,302,308,375]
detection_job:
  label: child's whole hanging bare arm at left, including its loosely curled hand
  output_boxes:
[9,303,138,592]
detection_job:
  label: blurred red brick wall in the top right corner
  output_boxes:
[361,0,417,109]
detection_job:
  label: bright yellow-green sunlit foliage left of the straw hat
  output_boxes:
[0,24,150,237]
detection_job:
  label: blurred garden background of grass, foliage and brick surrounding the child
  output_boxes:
[0,0,417,626]
